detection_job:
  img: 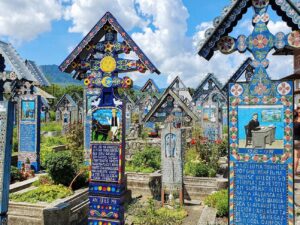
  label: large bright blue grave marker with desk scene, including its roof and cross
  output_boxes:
[199,0,300,225]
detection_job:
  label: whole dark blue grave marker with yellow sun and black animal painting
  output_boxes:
[60,12,159,225]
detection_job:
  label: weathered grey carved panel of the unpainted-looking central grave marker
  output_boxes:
[161,123,183,196]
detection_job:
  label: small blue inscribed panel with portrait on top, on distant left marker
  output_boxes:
[18,95,41,171]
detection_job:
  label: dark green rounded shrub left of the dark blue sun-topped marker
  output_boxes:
[45,151,76,186]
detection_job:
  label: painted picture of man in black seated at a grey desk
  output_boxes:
[238,105,284,149]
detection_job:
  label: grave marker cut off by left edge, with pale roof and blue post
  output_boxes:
[0,41,37,225]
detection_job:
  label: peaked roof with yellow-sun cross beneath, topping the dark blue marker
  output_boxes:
[60,12,160,91]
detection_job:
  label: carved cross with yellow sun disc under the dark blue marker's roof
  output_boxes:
[78,24,147,88]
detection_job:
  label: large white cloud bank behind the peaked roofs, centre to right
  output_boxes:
[62,0,292,88]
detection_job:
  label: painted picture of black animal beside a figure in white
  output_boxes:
[92,108,122,142]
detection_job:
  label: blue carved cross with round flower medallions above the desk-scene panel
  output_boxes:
[217,0,300,96]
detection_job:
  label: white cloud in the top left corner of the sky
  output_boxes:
[0,0,62,42]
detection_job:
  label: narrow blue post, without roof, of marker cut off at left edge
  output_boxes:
[0,101,14,224]
